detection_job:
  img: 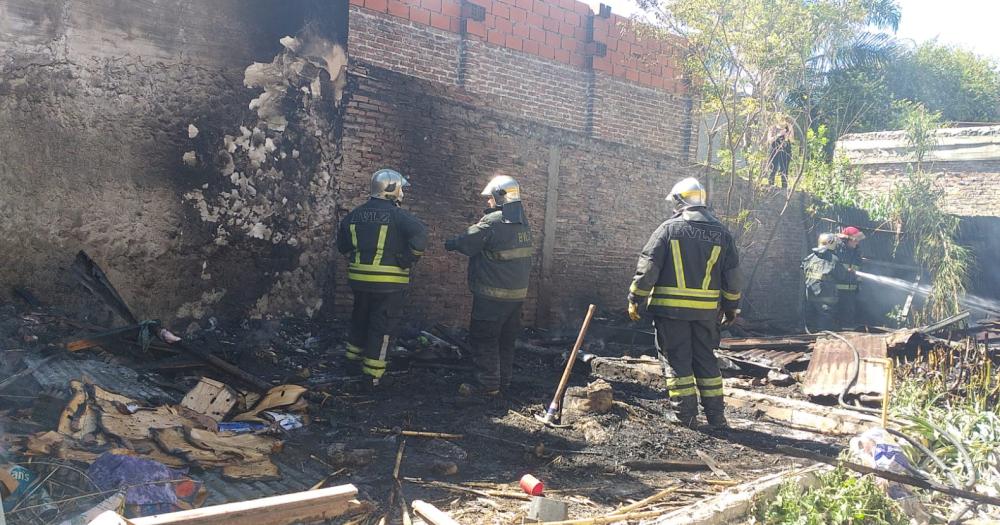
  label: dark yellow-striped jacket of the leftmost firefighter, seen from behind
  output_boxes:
[337,198,427,292]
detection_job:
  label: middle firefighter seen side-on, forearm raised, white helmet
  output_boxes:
[444,175,533,401]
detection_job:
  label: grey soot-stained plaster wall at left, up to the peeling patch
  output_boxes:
[0,0,346,319]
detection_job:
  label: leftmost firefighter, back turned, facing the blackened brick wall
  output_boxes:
[337,169,427,387]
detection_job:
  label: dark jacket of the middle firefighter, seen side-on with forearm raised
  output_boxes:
[445,202,533,301]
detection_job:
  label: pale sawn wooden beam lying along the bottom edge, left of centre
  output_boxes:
[120,485,360,525]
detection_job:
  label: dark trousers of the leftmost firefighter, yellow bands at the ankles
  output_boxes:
[347,290,405,379]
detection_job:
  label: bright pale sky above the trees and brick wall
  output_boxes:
[585,0,1000,62]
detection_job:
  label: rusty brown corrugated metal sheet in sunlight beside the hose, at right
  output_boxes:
[802,332,896,396]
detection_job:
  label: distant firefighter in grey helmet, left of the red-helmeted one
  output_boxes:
[802,233,848,331]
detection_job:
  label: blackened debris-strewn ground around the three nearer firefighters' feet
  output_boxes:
[0,296,843,524]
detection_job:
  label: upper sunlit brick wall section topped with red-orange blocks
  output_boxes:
[348,0,697,155]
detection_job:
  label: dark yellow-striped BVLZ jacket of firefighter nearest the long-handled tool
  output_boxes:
[629,207,743,321]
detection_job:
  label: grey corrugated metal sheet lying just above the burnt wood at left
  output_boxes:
[25,356,179,402]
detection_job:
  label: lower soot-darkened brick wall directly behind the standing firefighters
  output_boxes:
[335,63,805,326]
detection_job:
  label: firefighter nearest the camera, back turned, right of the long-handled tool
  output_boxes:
[628,178,742,429]
